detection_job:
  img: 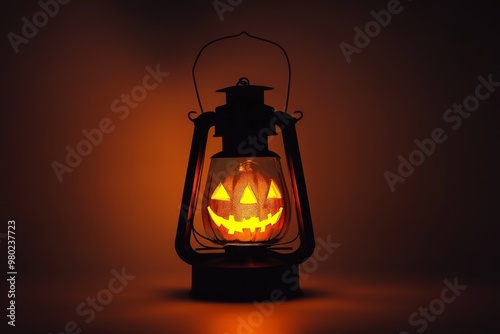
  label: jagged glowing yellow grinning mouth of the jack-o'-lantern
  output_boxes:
[207,206,283,234]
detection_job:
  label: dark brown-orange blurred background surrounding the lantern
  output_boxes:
[0,0,500,333]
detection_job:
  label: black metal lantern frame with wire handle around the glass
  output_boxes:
[175,32,315,301]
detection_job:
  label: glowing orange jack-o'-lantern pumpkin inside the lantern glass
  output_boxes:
[202,157,289,244]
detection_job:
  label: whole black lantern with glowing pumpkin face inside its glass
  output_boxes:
[175,32,315,301]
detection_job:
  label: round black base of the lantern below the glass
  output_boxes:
[190,246,302,302]
